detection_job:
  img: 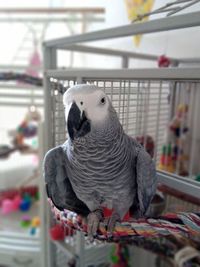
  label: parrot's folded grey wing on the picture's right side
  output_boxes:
[131,140,157,217]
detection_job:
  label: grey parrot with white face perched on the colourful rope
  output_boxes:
[44,84,157,239]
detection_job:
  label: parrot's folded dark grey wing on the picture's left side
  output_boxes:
[43,146,89,215]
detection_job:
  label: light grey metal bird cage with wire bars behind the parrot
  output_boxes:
[44,9,200,267]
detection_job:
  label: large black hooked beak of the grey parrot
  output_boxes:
[67,102,91,140]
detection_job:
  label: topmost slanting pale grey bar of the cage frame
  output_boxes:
[44,11,200,48]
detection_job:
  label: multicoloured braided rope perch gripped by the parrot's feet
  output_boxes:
[49,200,200,245]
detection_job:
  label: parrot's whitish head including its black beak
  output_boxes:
[63,84,117,140]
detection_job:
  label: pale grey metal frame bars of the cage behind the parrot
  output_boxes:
[43,12,200,267]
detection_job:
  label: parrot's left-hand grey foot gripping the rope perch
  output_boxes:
[87,209,103,242]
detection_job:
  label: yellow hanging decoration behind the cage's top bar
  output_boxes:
[125,0,154,46]
